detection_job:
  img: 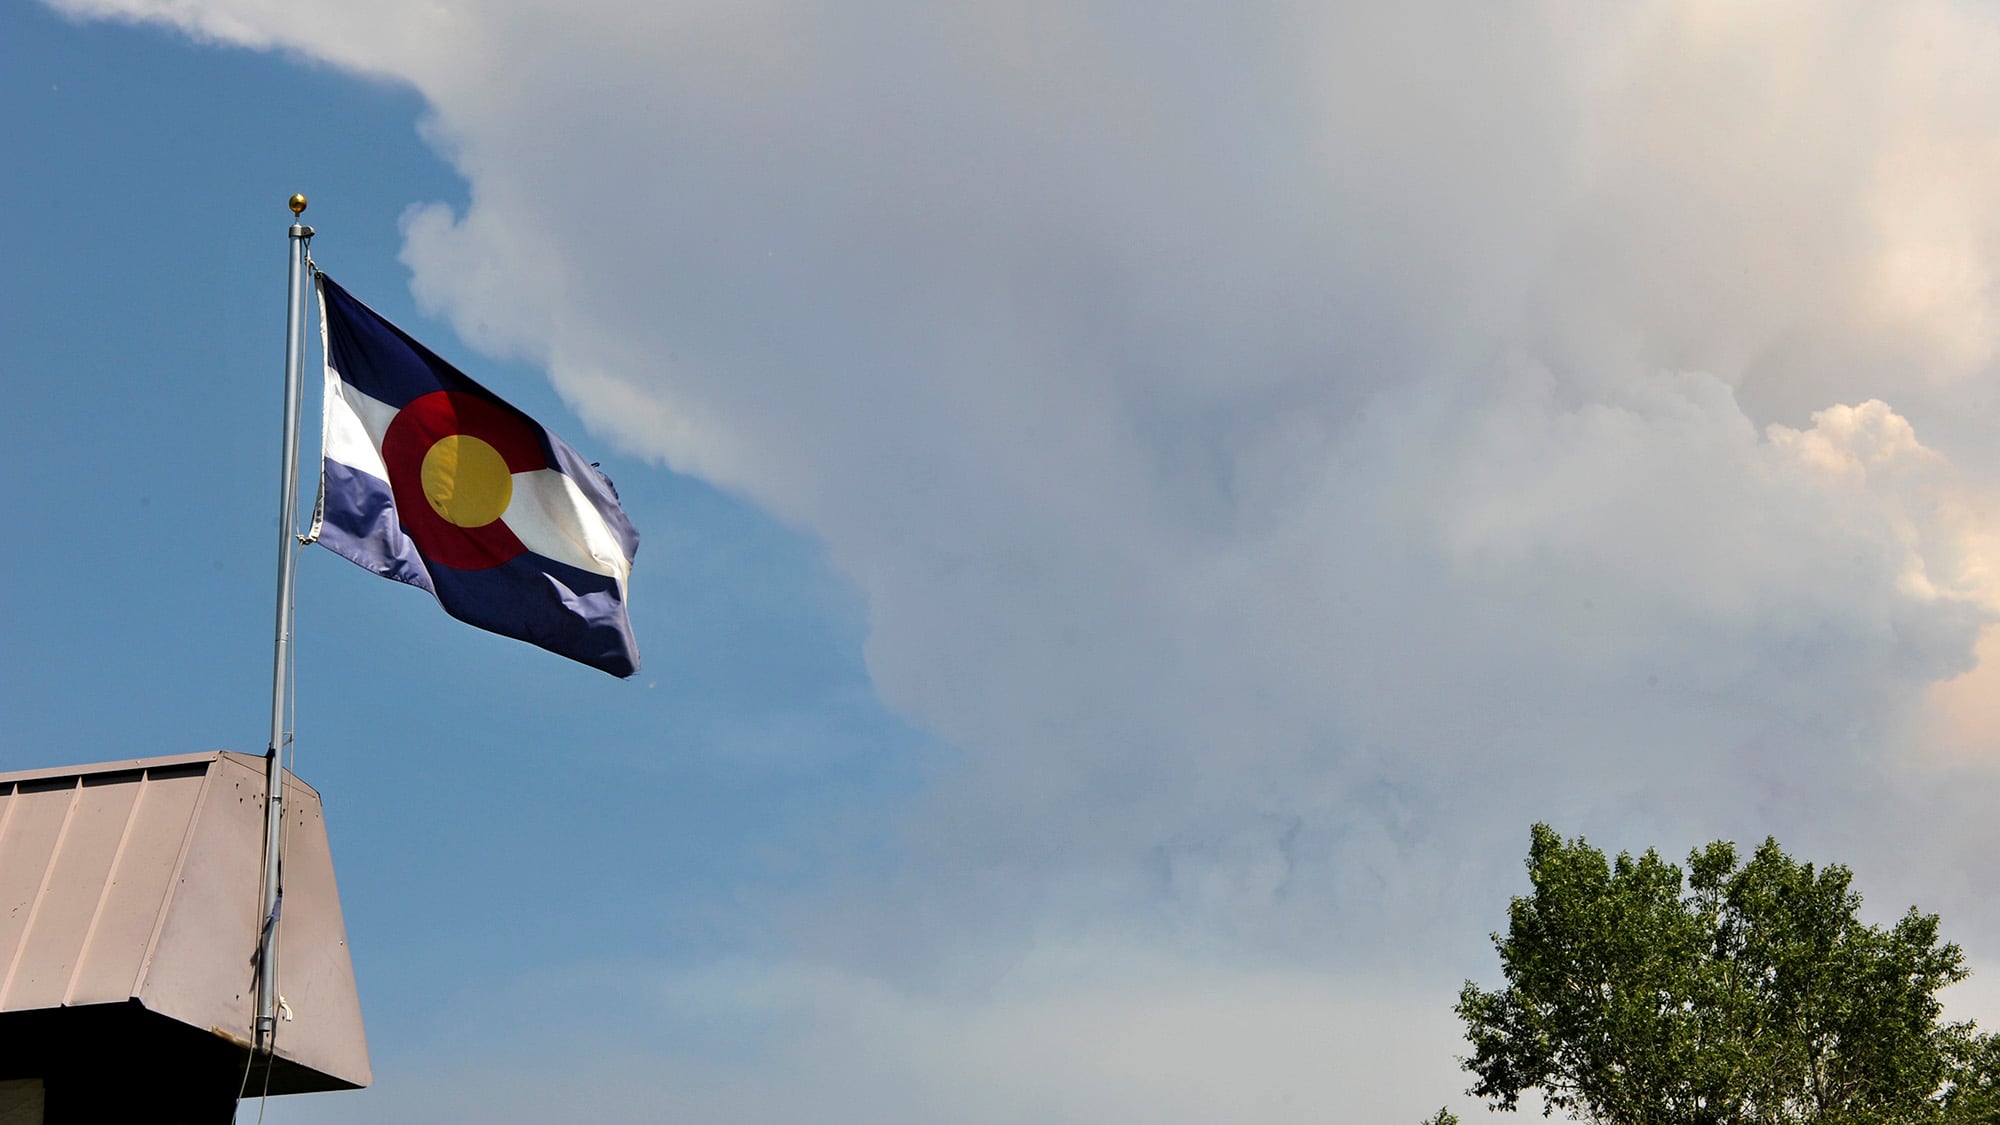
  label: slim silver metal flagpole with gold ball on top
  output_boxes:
[256,196,312,1051]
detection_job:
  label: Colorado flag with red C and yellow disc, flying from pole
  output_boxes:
[318,274,638,677]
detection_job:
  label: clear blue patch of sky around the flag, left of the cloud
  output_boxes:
[0,2,936,1104]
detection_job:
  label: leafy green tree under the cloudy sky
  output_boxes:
[1456,825,2000,1125]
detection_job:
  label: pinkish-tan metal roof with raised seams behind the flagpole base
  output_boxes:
[0,751,370,1093]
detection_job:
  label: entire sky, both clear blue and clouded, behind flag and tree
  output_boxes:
[19,0,2000,1123]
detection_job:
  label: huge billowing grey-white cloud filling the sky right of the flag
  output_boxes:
[64,0,2000,1119]
